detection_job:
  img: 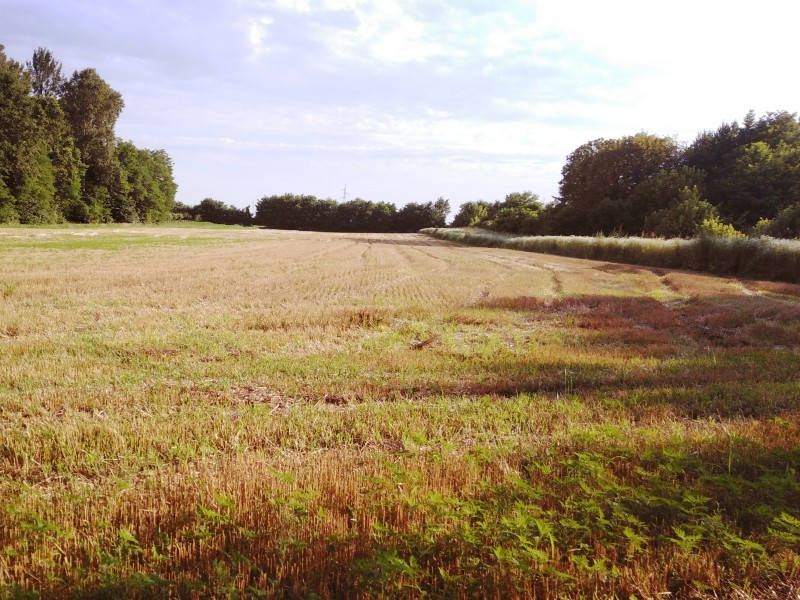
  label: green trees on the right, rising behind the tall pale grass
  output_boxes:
[453,111,800,238]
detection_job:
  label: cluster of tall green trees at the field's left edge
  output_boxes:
[0,45,177,224]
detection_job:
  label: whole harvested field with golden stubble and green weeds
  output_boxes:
[0,227,800,598]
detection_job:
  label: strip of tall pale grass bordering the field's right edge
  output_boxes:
[421,229,800,283]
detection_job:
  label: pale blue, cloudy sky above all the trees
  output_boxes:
[0,0,800,209]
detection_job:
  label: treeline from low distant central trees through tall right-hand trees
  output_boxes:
[194,112,800,238]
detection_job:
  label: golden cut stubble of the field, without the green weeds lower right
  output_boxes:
[0,227,800,597]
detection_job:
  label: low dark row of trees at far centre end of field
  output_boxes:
[254,194,450,233]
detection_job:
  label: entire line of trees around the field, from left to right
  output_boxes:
[0,45,800,238]
